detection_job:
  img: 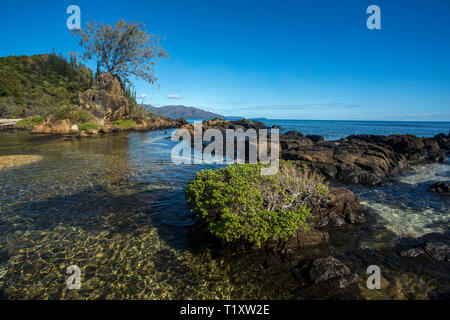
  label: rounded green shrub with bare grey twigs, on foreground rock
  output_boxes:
[186,161,329,246]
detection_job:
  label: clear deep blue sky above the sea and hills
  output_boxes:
[0,0,450,121]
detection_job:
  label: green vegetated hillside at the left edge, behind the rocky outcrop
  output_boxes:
[0,53,94,118]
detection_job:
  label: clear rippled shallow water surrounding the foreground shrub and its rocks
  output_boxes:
[0,131,449,299]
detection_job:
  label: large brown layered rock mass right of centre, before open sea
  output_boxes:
[280,132,447,185]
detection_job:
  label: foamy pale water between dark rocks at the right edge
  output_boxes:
[348,162,450,245]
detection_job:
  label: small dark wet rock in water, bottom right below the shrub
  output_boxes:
[292,256,359,289]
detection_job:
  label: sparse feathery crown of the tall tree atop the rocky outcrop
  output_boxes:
[75,20,168,83]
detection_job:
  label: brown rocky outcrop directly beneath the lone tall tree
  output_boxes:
[76,73,131,121]
